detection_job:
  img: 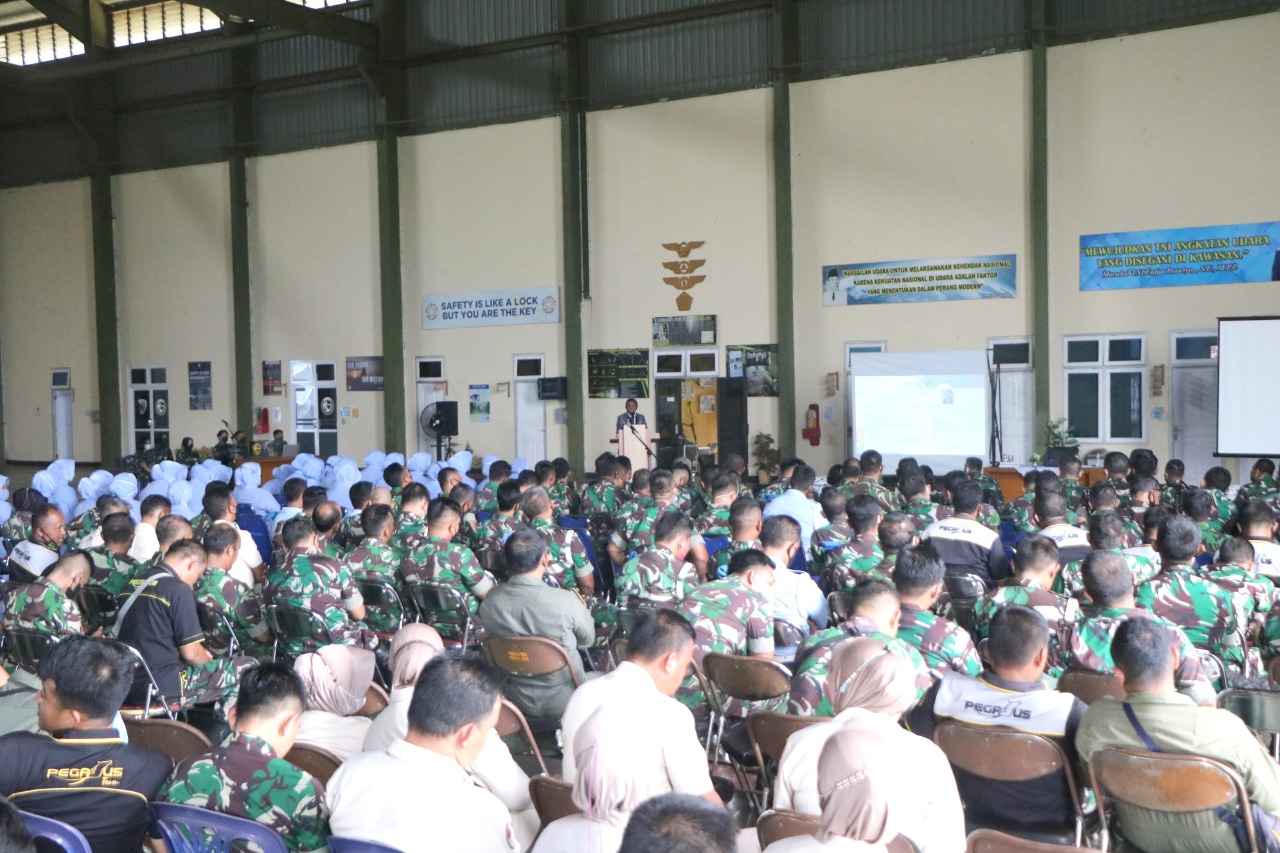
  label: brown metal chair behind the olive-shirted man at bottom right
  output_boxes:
[1089,747,1258,853]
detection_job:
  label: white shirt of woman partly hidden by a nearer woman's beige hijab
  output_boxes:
[769,708,965,853]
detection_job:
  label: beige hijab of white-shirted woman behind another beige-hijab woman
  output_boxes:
[827,637,916,720]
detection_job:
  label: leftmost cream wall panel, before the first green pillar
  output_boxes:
[0,181,101,462]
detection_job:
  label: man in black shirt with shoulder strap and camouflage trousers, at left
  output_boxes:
[116,539,253,716]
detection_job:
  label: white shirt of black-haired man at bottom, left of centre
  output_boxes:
[325,733,520,853]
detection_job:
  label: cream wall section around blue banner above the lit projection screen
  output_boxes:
[782,54,1030,473]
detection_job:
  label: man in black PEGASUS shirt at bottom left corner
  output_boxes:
[0,637,173,853]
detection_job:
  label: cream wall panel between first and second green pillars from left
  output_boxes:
[114,163,236,452]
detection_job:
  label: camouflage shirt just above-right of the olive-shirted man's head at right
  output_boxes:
[1135,565,1244,665]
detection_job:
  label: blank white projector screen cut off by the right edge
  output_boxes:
[1217,316,1280,456]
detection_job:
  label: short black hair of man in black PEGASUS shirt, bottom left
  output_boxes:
[37,635,137,720]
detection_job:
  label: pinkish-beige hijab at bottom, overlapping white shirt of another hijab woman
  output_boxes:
[817,726,900,844]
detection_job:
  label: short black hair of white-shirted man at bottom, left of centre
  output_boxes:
[408,653,515,738]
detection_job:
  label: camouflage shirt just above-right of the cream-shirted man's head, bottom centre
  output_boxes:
[676,575,773,708]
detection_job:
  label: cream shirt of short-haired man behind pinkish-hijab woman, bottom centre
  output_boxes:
[561,661,712,802]
